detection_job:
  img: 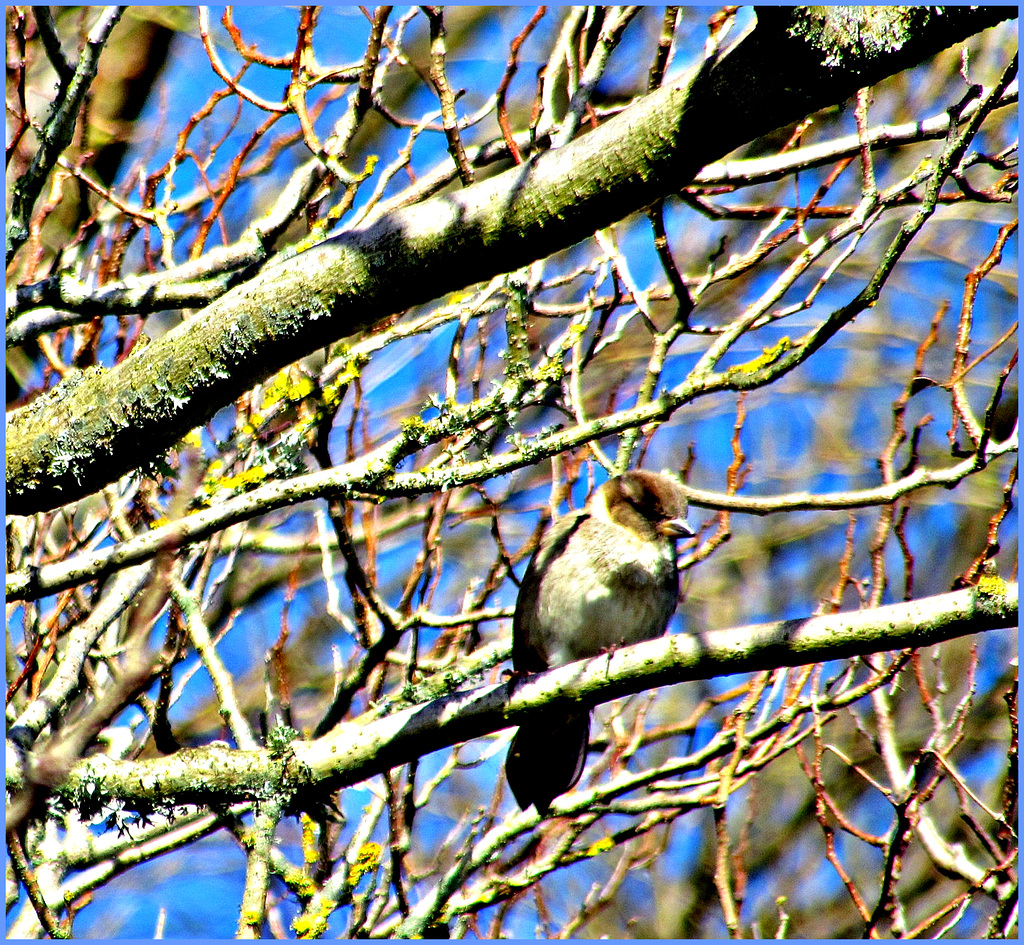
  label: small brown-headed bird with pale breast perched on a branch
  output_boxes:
[505,471,694,815]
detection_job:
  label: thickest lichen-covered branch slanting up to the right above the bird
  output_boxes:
[7,7,1014,514]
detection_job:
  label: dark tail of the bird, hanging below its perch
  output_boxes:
[505,712,590,814]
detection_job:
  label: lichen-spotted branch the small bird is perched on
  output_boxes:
[49,577,1018,810]
